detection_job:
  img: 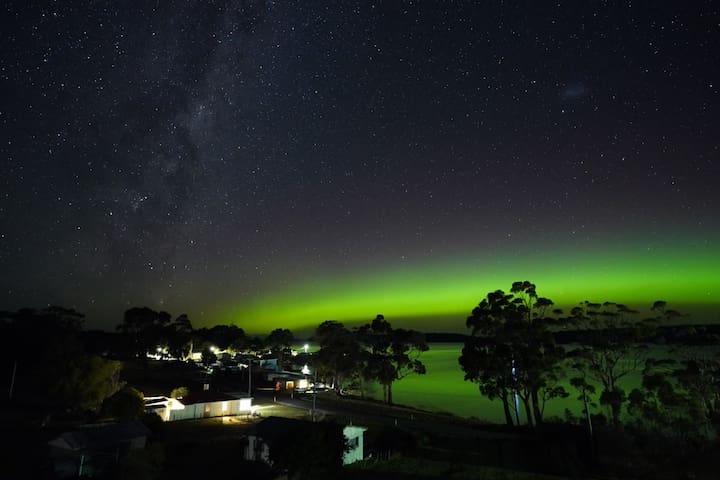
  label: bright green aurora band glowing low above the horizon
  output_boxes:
[218,237,720,333]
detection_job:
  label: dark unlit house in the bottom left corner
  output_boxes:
[48,421,150,478]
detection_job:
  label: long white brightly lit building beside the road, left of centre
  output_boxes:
[145,390,252,422]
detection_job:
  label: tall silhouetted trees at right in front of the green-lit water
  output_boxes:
[459,281,720,434]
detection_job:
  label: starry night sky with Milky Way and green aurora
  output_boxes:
[0,0,720,333]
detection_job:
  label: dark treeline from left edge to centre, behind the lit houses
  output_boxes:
[0,307,427,418]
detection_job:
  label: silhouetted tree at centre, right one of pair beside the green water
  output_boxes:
[357,315,428,405]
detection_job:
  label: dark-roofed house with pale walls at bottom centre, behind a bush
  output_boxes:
[244,417,367,465]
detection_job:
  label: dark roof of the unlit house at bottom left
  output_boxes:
[48,421,150,450]
